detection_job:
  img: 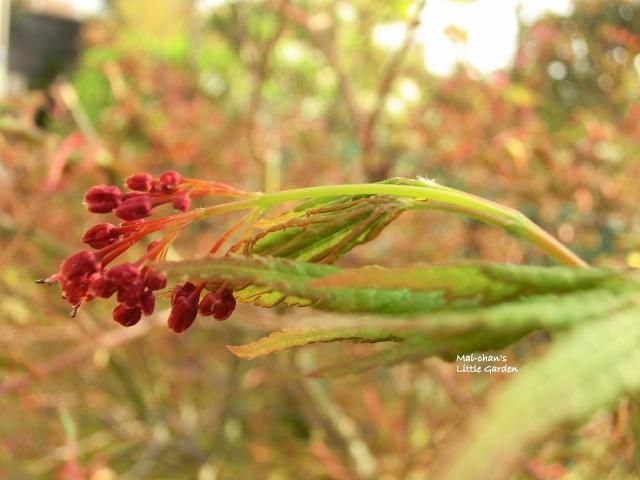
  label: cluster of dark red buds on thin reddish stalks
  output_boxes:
[40,171,246,333]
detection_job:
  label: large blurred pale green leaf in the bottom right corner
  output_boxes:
[430,308,640,480]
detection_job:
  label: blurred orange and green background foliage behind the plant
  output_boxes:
[0,0,640,480]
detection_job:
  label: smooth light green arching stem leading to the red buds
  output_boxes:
[201,183,588,267]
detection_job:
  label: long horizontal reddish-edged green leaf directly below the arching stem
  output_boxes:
[158,257,631,314]
